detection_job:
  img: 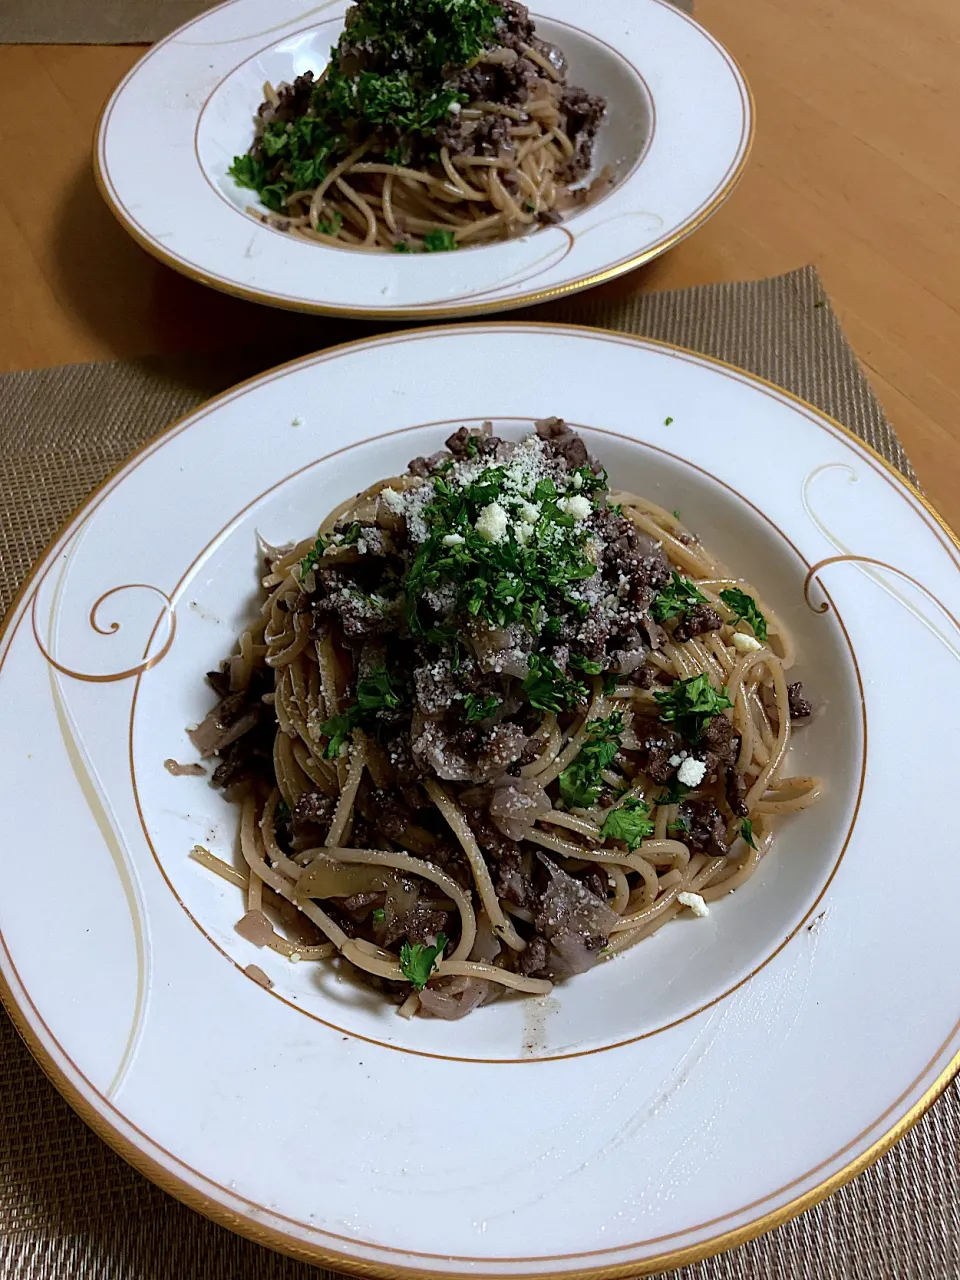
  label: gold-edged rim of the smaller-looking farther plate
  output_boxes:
[92,0,756,321]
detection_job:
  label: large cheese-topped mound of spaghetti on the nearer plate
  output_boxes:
[192,419,820,1018]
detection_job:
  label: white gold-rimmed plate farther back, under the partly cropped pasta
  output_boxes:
[95,0,753,319]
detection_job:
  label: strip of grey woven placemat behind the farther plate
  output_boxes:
[0,0,694,45]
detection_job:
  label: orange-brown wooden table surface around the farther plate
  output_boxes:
[0,0,960,529]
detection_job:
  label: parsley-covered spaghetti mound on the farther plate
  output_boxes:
[230,0,611,252]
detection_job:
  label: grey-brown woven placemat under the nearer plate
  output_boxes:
[0,268,960,1280]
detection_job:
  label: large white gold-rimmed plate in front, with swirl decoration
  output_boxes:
[0,324,960,1277]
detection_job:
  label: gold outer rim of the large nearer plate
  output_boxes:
[0,320,960,1280]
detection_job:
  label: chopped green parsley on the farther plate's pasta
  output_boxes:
[229,0,503,212]
